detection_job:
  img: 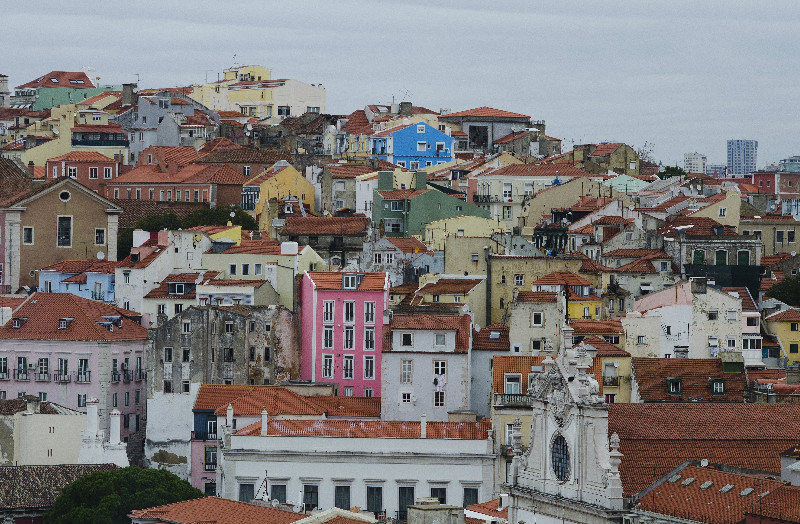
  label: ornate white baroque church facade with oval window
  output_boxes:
[506,344,624,524]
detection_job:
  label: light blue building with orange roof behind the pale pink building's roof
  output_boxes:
[39,260,117,303]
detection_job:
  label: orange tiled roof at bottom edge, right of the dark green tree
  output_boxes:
[129,497,307,524]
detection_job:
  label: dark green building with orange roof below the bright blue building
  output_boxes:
[372,171,489,236]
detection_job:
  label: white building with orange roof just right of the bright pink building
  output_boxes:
[381,313,472,421]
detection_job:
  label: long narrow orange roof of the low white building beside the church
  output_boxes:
[235,418,492,440]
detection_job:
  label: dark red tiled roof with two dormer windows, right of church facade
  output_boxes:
[632,357,746,402]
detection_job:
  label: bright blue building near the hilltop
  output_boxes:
[372,122,453,169]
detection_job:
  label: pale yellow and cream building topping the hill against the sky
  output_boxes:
[189,65,326,124]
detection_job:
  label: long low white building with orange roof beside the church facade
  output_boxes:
[217,412,494,520]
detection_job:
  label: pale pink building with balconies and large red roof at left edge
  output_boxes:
[0,293,147,441]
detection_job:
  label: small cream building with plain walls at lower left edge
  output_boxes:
[0,398,86,466]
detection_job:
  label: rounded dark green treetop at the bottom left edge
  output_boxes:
[44,466,205,524]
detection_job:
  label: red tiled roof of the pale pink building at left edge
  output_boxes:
[0,293,147,341]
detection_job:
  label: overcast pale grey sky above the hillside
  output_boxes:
[6,0,800,166]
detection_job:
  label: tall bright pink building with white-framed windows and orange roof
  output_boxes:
[300,271,389,397]
